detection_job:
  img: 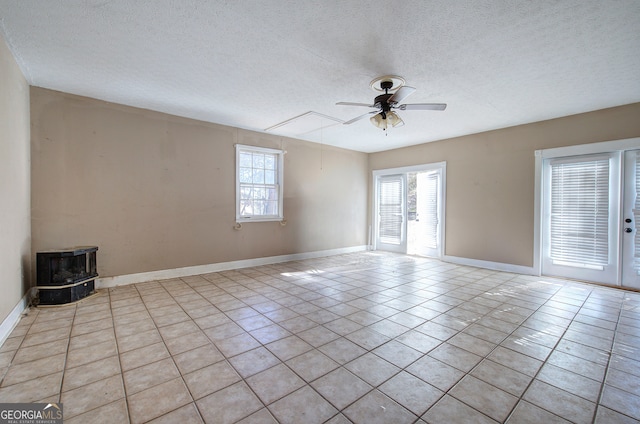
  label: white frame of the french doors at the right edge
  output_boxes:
[533,137,640,286]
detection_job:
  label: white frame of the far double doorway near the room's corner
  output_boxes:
[370,162,447,258]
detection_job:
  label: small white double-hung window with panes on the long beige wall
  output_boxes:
[236,144,284,222]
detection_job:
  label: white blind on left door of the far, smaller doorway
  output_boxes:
[378,175,404,244]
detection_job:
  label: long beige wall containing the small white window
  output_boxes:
[31,87,368,277]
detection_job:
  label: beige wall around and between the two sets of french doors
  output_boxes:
[369,103,640,266]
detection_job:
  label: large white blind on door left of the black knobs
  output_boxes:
[550,157,609,269]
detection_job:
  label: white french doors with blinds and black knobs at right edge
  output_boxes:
[542,150,640,288]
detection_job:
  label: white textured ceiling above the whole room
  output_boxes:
[0,0,640,152]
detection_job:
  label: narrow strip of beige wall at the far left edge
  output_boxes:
[0,38,31,323]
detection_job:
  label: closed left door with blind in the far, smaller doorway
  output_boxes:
[376,174,407,253]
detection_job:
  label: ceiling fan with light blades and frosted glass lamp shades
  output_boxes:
[336,75,447,131]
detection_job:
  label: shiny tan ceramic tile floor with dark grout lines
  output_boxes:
[0,252,640,424]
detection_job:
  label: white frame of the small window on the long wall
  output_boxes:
[235,144,284,223]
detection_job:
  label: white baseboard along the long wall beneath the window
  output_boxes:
[96,246,367,288]
